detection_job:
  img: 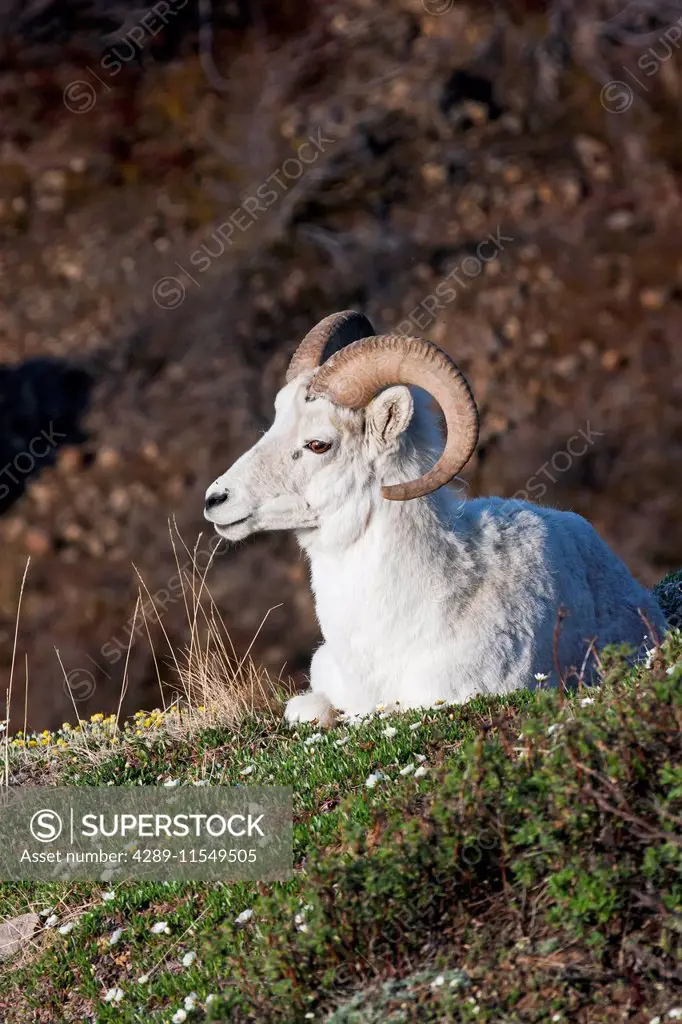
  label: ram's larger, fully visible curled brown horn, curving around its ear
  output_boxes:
[309,331,478,502]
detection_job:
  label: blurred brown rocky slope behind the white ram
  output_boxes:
[0,0,682,728]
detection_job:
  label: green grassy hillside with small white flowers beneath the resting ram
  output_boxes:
[0,632,682,1024]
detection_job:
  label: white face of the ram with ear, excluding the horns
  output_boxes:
[204,374,413,541]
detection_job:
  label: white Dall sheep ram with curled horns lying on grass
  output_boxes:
[205,311,666,725]
